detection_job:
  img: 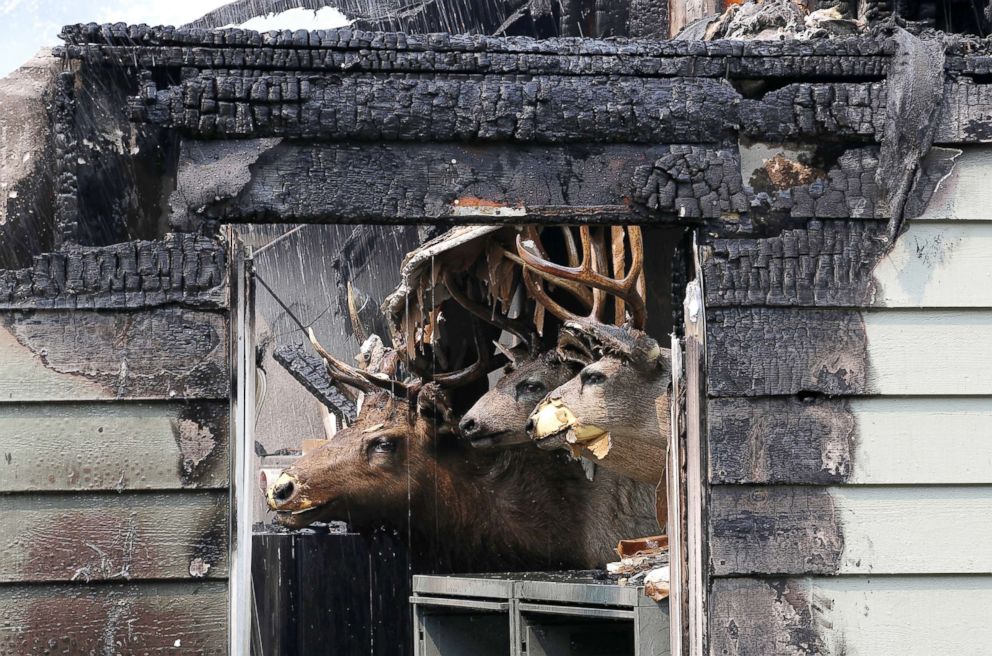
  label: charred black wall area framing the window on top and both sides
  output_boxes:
[0,20,992,654]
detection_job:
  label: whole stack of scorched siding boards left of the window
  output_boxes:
[0,235,231,654]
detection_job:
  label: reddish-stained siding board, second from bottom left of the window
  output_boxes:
[0,491,228,583]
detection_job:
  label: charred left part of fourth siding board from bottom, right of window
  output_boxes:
[707,308,868,396]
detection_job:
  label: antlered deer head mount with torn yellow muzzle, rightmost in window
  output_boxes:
[517,226,671,484]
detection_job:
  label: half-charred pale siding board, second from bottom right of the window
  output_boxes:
[709,485,992,576]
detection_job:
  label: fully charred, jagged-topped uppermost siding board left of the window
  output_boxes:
[0,234,227,309]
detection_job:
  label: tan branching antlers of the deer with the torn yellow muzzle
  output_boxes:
[517,226,647,330]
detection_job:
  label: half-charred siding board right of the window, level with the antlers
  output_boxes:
[703,221,992,308]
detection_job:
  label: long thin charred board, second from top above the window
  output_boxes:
[66,42,888,81]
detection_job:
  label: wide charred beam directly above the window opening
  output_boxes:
[177,142,680,223]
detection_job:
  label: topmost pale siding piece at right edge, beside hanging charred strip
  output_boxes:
[913,146,992,221]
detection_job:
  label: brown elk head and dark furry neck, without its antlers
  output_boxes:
[273,393,626,572]
